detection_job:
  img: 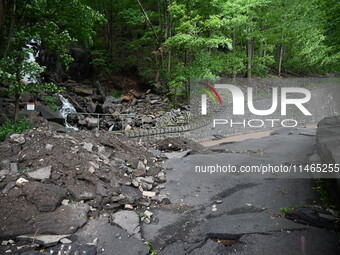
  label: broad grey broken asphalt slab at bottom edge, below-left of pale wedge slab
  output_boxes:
[74,217,149,255]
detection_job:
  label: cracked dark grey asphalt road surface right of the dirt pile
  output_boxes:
[142,129,340,255]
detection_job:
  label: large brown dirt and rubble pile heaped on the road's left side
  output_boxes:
[0,129,165,236]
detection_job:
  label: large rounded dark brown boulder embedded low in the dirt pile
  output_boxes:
[23,182,67,212]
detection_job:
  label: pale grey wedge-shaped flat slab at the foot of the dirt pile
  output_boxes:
[112,211,141,239]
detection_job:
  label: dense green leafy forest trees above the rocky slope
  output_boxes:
[0,0,340,109]
